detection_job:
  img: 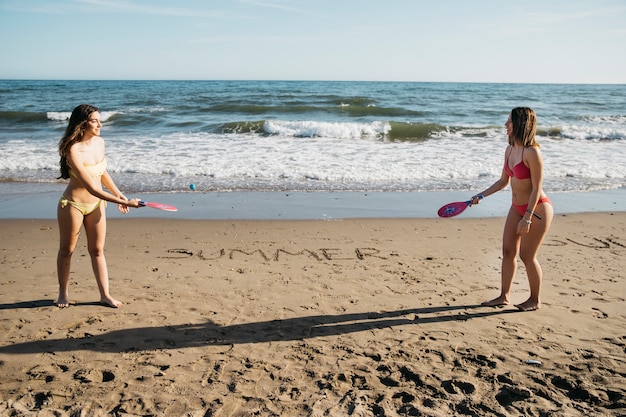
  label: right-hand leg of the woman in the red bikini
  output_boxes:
[516,203,554,311]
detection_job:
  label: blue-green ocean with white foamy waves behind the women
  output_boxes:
[0,80,626,195]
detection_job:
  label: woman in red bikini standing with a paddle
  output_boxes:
[470,107,554,311]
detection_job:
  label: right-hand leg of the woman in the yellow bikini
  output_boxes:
[83,204,122,308]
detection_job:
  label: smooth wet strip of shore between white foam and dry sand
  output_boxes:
[0,182,626,220]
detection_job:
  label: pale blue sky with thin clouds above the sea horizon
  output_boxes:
[0,0,626,84]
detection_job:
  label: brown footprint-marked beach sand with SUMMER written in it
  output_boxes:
[0,212,626,416]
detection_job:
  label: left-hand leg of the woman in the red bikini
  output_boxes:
[481,207,522,307]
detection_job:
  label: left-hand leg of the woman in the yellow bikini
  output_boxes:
[54,203,83,308]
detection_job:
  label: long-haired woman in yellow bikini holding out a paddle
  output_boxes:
[55,104,140,308]
